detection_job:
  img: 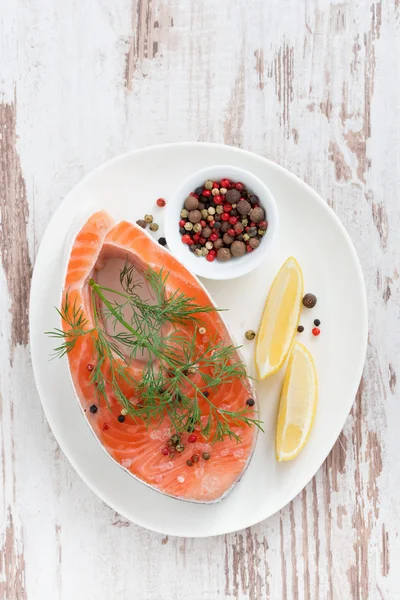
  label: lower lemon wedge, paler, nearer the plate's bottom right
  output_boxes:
[276,342,318,462]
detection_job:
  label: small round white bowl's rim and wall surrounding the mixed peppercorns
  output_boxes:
[164,165,279,279]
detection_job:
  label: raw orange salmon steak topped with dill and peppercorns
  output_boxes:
[54,211,260,503]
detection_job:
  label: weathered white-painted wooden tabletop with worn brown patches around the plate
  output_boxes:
[0,0,400,600]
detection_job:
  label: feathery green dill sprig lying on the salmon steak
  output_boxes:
[46,263,262,442]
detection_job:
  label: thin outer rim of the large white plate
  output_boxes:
[29,141,368,538]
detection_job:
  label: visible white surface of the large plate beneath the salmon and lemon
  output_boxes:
[30,143,367,537]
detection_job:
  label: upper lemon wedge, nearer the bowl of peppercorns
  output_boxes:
[255,257,303,379]
